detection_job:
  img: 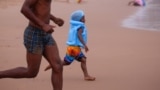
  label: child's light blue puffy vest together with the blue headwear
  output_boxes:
[66,10,87,47]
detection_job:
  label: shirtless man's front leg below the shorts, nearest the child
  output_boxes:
[44,44,63,90]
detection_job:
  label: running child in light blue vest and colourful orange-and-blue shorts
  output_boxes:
[45,10,95,81]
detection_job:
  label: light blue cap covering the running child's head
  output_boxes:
[71,10,84,21]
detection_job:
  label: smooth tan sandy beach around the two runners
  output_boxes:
[0,0,160,90]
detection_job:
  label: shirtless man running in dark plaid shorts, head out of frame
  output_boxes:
[0,0,64,90]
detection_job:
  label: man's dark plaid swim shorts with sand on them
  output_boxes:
[24,26,55,54]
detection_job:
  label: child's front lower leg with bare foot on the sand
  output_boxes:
[81,58,96,81]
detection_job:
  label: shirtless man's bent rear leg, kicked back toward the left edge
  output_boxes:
[0,53,42,78]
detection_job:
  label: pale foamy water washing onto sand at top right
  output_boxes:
[122,0,160,31]
